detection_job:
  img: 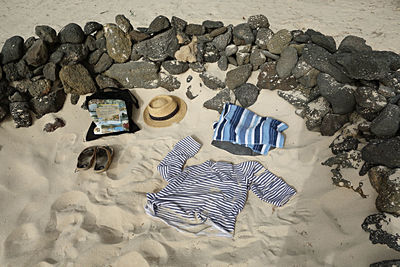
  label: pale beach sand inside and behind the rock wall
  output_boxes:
[0,0,400,267]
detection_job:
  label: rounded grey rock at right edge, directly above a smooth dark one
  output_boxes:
[371,104,400,137]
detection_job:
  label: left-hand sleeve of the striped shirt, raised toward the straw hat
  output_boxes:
[157,136,201,182]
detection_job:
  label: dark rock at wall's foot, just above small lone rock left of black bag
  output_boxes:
[30,89,66,119]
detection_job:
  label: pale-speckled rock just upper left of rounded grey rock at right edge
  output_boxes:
[354,87,387,112]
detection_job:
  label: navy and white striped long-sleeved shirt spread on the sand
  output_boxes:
[145,136,296,237]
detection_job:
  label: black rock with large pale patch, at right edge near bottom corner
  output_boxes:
[361,213,400,252]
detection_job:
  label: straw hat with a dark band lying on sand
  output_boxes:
[143,95,187,127]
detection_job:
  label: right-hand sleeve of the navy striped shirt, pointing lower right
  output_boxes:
[250,170,296,207]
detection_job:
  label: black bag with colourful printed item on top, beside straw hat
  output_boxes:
[85,88,140,141]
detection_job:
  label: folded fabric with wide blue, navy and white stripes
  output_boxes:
[213,103,288,155]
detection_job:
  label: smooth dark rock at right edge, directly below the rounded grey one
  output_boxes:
[361,137,400,168]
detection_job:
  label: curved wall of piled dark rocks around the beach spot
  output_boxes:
[0,15,400,255]
